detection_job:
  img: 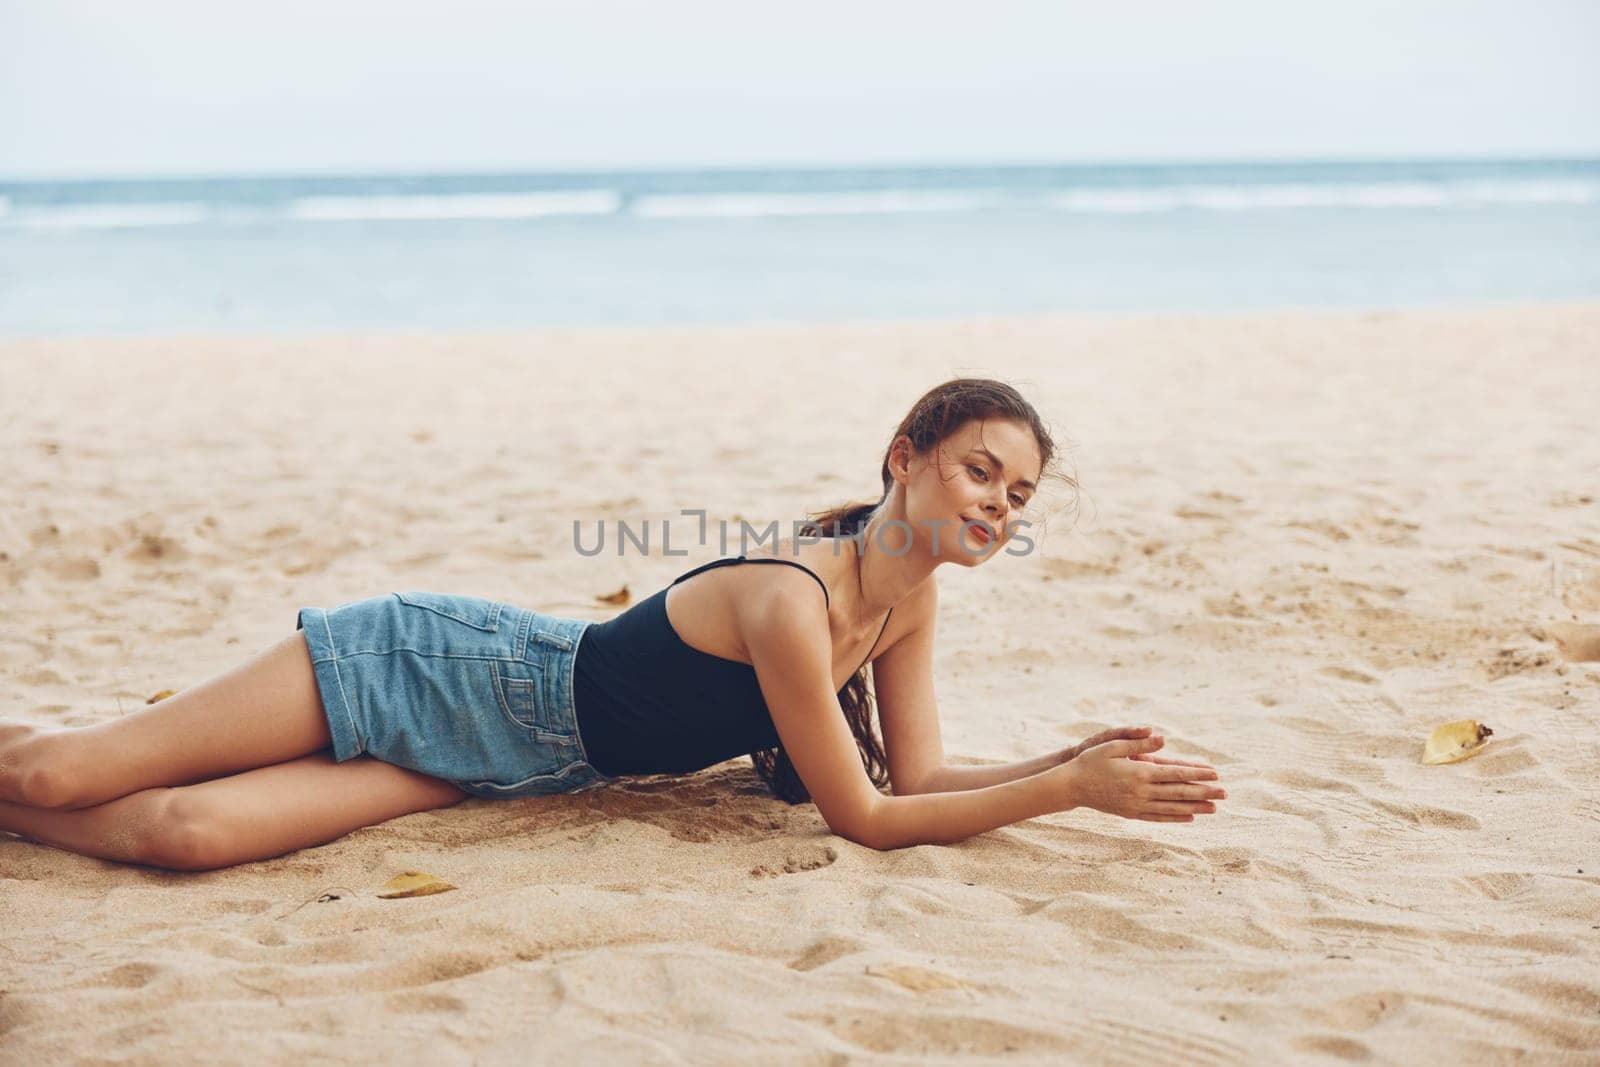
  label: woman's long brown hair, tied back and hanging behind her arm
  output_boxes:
[750,378,1077,805]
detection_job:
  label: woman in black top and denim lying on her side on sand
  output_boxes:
[0,379,1226,870]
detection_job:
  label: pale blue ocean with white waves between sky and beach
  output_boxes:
[0,160,1600,338]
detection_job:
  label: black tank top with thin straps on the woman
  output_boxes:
[573,555,894,777]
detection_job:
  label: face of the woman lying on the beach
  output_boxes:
[885,419,1043,566]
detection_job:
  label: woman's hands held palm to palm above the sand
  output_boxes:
[1061,726,1227,822]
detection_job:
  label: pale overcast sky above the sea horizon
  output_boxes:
[0,0,1600,178]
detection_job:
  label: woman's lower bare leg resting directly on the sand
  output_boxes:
[0,752,467,870]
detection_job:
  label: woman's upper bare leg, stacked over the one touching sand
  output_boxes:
[0,630,333,809]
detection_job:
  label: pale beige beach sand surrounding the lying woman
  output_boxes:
[0,304,1600,1064]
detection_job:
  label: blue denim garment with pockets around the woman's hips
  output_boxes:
[294,592,610,798]
